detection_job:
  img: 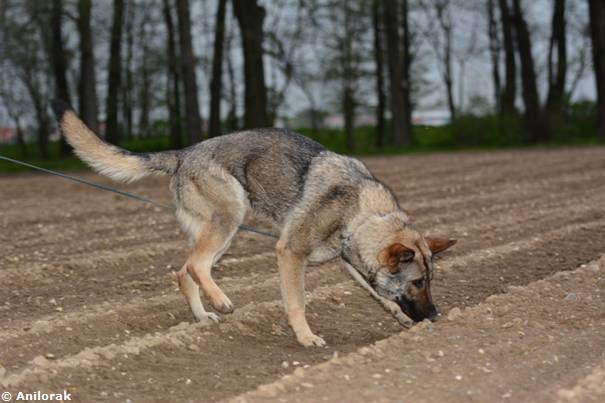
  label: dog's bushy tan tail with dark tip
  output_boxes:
[52,100,179,182]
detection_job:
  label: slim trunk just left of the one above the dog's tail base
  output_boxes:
[164,0,182,148]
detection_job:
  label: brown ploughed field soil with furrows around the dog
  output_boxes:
[0,148,605,402]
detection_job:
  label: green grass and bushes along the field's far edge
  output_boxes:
[0,116,605,173]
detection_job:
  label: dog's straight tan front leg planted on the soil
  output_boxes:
[276,241,326,347]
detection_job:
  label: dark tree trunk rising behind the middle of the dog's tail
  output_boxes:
[78,0,99,133]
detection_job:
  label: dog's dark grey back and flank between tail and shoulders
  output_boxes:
[176,128,328,222]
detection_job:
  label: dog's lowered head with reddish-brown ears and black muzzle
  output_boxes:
[343,221,456,322]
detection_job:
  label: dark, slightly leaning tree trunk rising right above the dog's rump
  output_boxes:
[176,0,202,145]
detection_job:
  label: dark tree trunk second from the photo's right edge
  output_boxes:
[546,0,567,123]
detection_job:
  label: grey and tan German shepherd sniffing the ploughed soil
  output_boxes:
[54,102,455,346]
